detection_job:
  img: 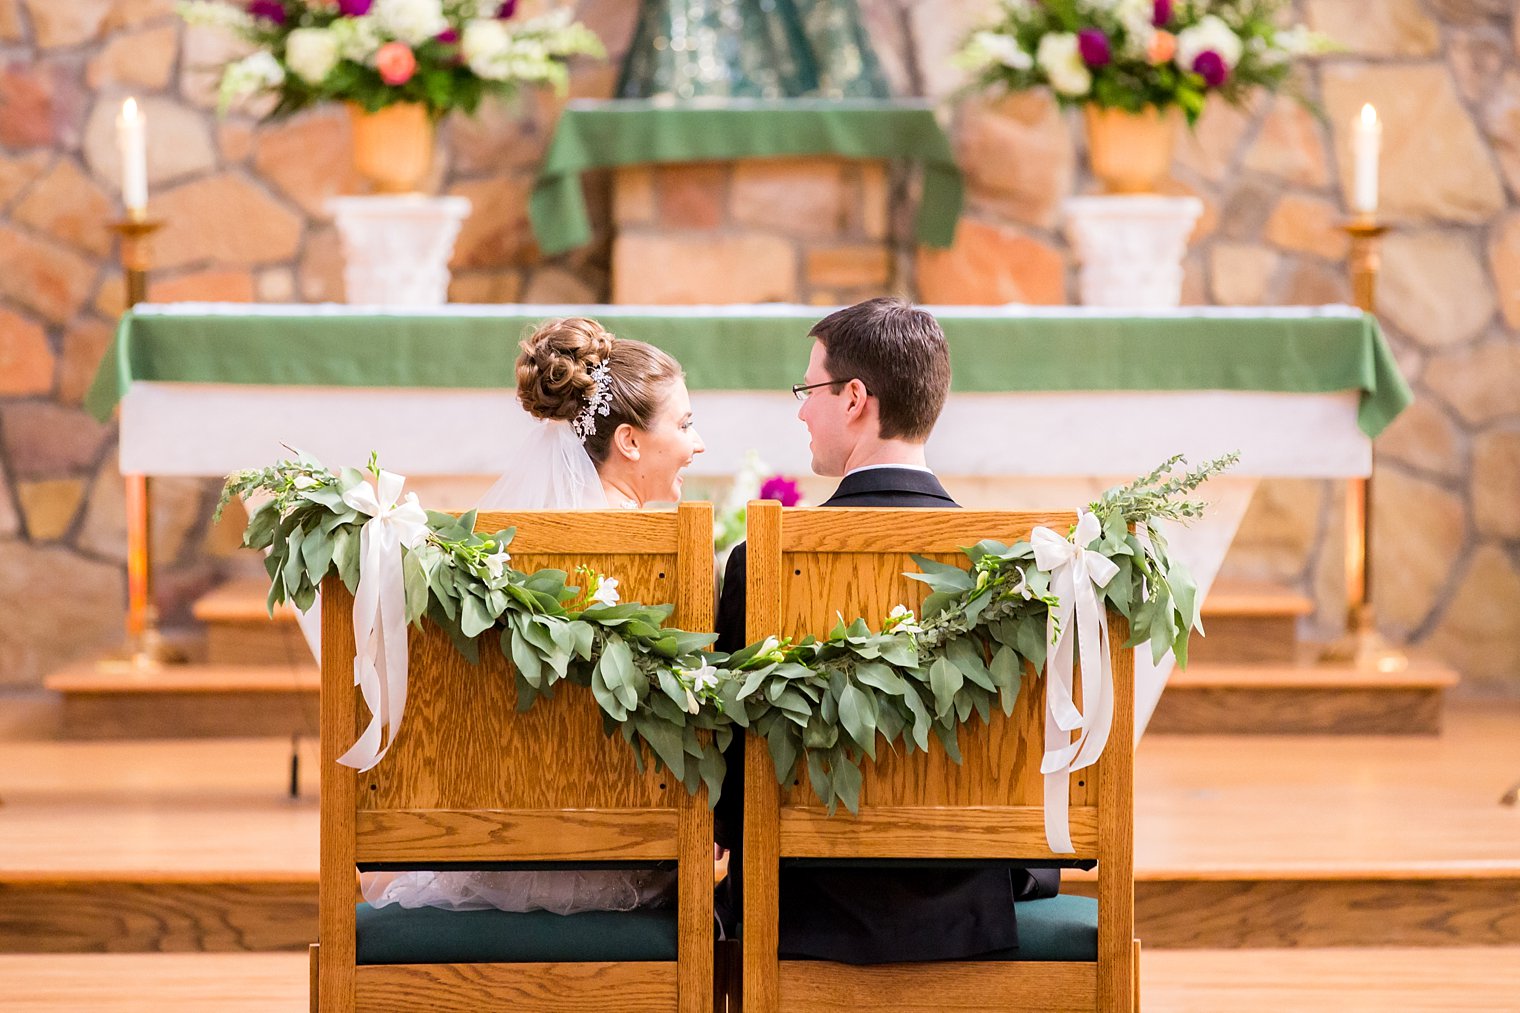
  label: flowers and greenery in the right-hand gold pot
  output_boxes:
[958,0,1332,123]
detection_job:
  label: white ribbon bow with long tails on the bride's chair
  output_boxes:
[337,472,429,771]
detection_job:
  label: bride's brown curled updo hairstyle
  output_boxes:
[517,316,681,464]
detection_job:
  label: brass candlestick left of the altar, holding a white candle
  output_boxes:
[103,210,185,669]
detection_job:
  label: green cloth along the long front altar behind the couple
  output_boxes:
[85,306,1411,437]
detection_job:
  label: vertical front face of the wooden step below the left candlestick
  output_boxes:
[59,689,319,739]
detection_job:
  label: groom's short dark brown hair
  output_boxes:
[809,297,950,443]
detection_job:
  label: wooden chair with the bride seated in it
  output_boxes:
[313,503,713,1013]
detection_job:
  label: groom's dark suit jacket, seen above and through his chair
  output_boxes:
[716,468,1061,964]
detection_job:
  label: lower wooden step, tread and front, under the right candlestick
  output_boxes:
[1146,659,1458,735]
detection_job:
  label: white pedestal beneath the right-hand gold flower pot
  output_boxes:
[1064,195,1204,309]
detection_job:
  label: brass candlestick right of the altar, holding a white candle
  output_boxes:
[1322,213,1409,672]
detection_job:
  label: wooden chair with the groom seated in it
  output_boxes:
[743,502,1137,1013]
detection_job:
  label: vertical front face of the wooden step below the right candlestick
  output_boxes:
[1146,686,1442,735]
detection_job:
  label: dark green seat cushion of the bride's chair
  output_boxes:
[356,903,676,964]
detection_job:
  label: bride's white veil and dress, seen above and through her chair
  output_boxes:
[355,421,676,914]
